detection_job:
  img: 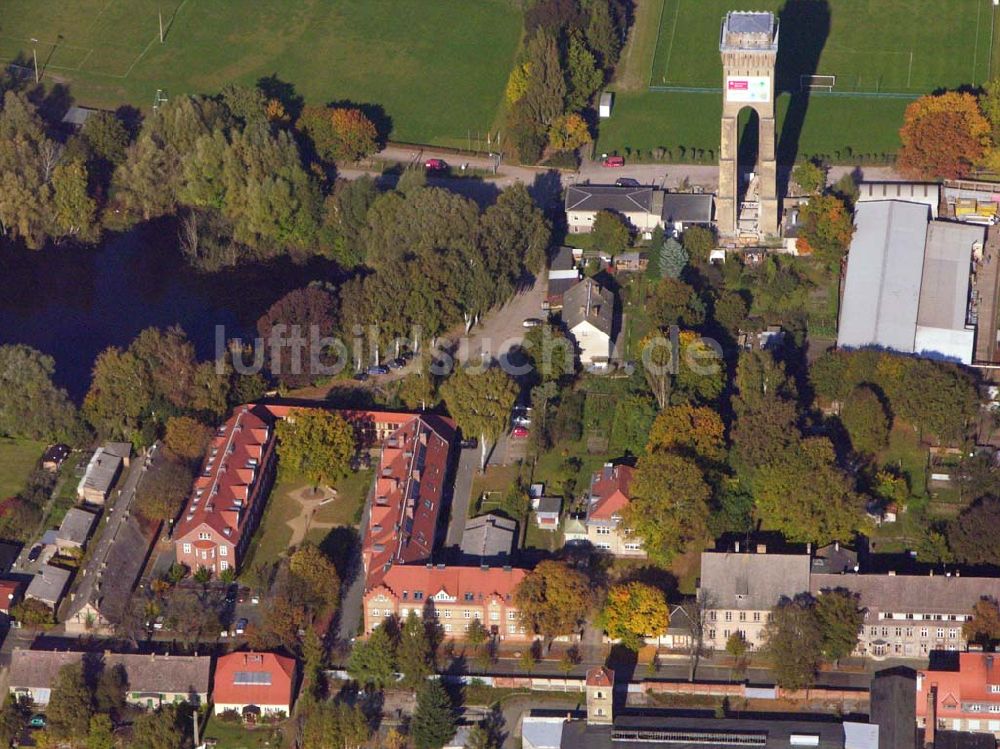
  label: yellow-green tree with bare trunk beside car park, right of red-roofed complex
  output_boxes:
[441,366,517,460]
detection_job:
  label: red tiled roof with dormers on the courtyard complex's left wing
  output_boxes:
[174,406,274,545]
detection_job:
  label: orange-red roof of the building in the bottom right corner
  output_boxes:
[917,653,1000,718]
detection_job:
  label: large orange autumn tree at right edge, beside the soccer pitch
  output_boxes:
[896,91,991,180]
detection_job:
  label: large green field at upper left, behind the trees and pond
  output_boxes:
[0,0,521,145]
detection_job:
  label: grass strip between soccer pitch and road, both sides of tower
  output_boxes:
[597,91,909,164]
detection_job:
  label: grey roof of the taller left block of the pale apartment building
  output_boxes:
[699,551,810,611]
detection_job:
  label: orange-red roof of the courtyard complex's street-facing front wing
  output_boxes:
[369,564,527,602]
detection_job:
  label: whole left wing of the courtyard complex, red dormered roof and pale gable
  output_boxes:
[173,405,277,575]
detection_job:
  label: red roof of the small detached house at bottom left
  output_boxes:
[212,652,295,709]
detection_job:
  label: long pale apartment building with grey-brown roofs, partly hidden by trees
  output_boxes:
[698,545,1000,659]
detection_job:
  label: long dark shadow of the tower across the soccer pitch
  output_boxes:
[775,0,836,180]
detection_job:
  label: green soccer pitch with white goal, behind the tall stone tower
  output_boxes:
[650,0,994,94]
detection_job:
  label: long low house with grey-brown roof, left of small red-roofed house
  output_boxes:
[8,648,212,709]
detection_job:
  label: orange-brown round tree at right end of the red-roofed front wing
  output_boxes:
[514,560,593,641]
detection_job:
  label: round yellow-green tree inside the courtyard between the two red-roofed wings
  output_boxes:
[277,408,355,486]
